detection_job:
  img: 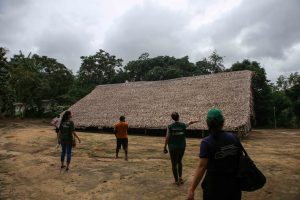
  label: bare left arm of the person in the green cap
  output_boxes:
[187,158,208,200]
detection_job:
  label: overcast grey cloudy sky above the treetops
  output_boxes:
[0,0,300,81]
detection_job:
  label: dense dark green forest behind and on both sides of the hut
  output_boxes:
[0,47,300,128]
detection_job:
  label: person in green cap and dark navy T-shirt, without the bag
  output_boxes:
[187,109,241,200]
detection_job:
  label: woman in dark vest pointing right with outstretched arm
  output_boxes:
[164,112,198,186]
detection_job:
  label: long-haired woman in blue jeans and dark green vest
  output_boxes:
[59,111,81,171]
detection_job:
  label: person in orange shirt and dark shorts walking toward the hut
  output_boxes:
[114,116,128,160]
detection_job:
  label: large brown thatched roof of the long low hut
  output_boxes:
[70,71,252,130]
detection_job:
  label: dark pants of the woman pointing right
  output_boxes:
[169,149,185,182]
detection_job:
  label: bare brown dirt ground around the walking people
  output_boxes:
[0,120,300,200]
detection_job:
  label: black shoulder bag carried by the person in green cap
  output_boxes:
[237,143,266,192]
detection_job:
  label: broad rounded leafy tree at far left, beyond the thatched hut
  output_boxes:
[9,52,73,112]
